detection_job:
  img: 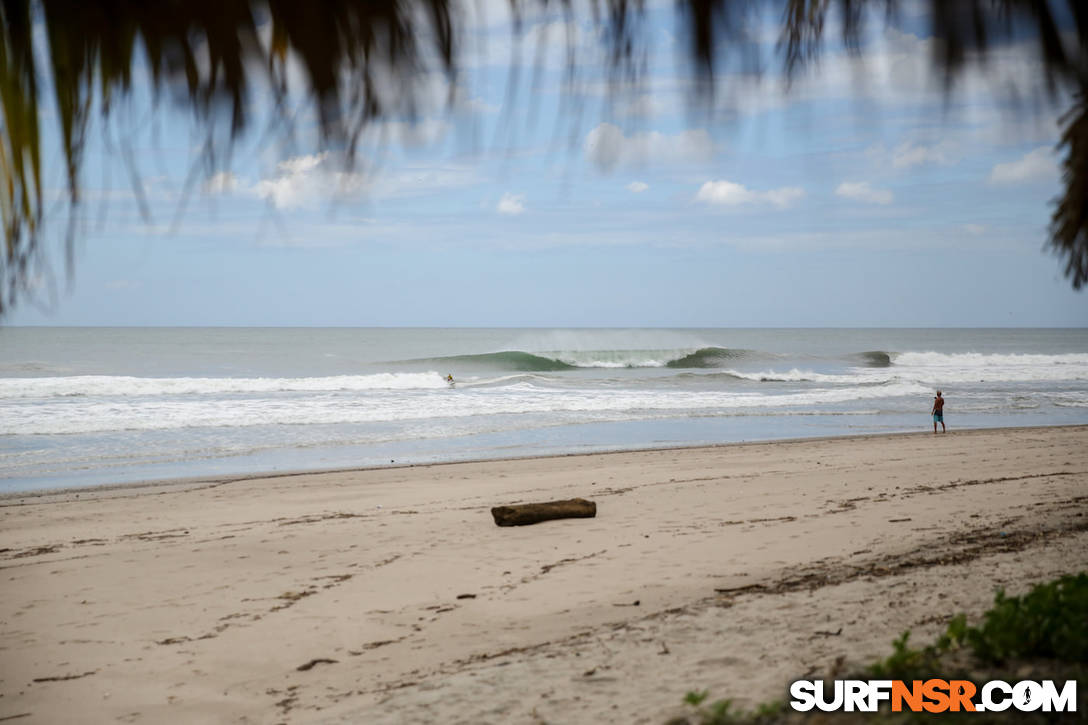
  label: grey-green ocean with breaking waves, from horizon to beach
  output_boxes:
[0,328,1088,492]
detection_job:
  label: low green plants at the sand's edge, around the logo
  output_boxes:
[668,573,1088,725]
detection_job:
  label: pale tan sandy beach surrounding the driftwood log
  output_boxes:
[0,427,1088,724]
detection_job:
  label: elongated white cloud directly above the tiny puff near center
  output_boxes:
[583,123,714,171]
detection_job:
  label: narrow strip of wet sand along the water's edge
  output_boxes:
[0,422,1088,507]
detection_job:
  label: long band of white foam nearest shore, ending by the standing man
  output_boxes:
[0,378,929,435]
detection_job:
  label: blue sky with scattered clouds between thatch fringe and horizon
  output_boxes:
[9,1,1088,327]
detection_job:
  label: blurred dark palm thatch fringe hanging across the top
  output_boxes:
[0,0,1088,317]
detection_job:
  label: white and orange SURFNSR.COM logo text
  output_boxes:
[790,679,1077,713]
